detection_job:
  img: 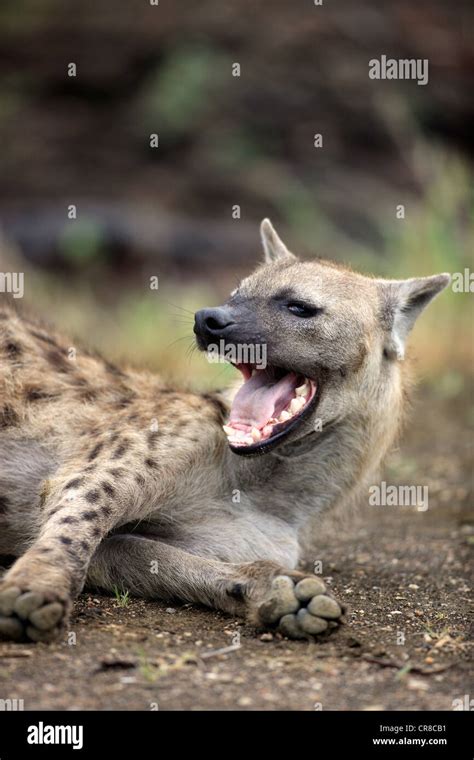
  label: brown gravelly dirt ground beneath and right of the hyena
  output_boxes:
[0,391,474,710]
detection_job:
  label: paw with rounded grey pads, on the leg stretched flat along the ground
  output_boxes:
[257,575,343,639]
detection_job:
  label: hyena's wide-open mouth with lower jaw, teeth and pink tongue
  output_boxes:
[224,364,320,455]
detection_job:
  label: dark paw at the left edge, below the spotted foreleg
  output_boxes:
[0,586,67,641]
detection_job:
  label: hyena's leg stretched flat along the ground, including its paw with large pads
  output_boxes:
[88,535,343,638]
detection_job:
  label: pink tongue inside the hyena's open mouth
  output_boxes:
[229,370,298,430]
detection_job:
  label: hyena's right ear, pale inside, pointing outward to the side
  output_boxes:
[378,273,451,359]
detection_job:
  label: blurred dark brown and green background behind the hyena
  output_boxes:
[0,0,474,392]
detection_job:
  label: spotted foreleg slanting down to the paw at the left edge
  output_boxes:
[0,471,128,641]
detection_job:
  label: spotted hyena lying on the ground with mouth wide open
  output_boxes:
[0,220,449,641]
